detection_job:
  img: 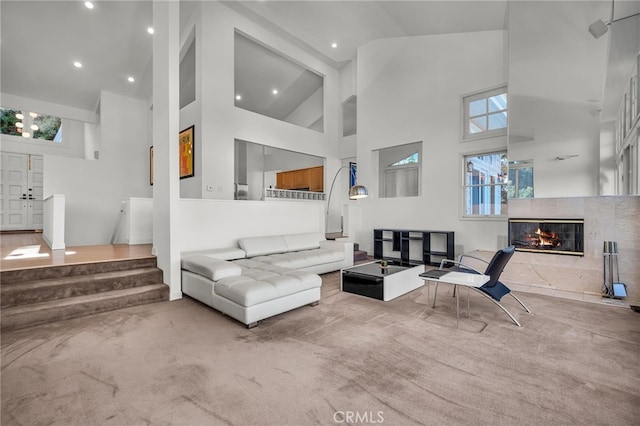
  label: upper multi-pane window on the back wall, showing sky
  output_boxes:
[463,86,507,140]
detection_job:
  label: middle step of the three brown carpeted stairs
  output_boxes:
[1,267,162,308]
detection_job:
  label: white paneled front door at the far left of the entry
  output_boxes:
[0,152,44,231]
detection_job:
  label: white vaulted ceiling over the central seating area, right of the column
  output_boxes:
[223,0,508,67]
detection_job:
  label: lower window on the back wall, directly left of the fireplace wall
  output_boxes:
[464,151,509,217]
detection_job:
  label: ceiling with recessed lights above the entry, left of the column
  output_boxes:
[0,0,153,110]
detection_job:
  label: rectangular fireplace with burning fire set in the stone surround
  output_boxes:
[509,219,584,256]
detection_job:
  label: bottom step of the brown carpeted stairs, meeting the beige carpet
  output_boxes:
[1,284,169,331]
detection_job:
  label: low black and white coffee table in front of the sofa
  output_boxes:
[340,261,425,302]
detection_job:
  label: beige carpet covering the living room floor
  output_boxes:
[0,272,640,426]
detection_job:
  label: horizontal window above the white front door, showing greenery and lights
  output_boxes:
[0,107,62,142]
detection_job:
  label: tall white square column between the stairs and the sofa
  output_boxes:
[153,0,182,300]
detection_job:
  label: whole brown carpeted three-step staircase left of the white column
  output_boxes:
[0,257,169,331]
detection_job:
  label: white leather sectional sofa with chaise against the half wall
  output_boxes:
[182,233,353,328]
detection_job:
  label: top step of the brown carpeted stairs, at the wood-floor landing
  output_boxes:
[0,256,157,286]
